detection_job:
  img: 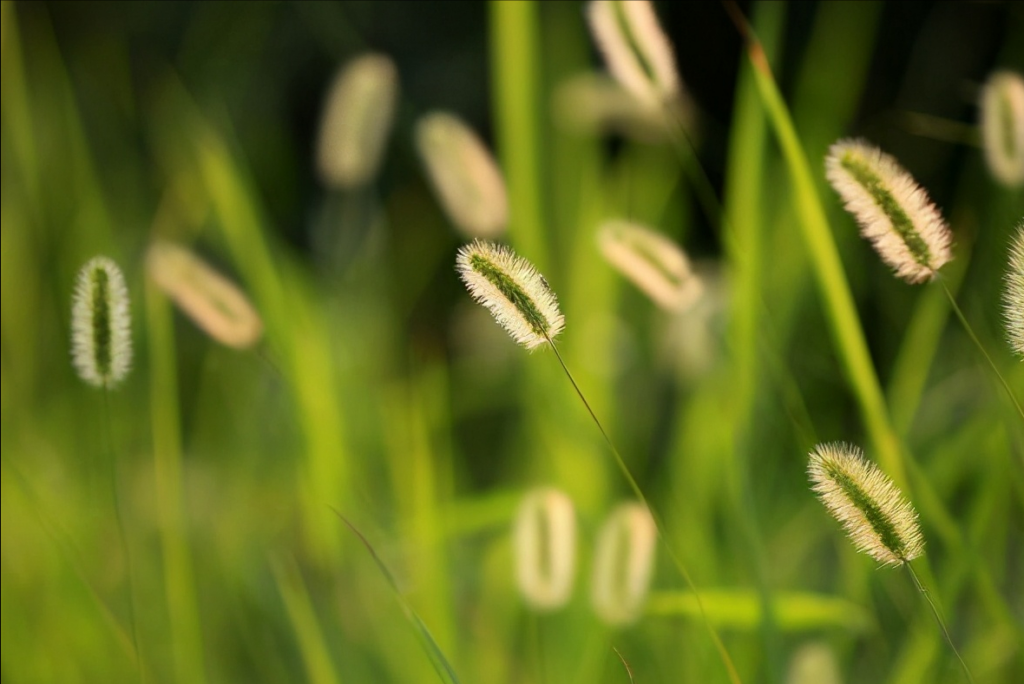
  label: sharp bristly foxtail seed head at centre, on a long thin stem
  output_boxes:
[456,240,565,349]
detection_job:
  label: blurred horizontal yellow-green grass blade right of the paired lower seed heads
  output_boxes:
[647,589,871,632]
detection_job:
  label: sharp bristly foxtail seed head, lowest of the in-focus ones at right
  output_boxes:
[807,443,925,565]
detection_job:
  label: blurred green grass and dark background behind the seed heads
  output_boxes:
[0,1,1024,684]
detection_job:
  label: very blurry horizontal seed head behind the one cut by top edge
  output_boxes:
[552,72,693,143]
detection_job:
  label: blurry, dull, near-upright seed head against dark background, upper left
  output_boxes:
[316,54,398,188]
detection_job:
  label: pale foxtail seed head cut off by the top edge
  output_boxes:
[587,0,680,109]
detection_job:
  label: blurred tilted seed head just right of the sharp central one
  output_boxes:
[598,220,702,311]
